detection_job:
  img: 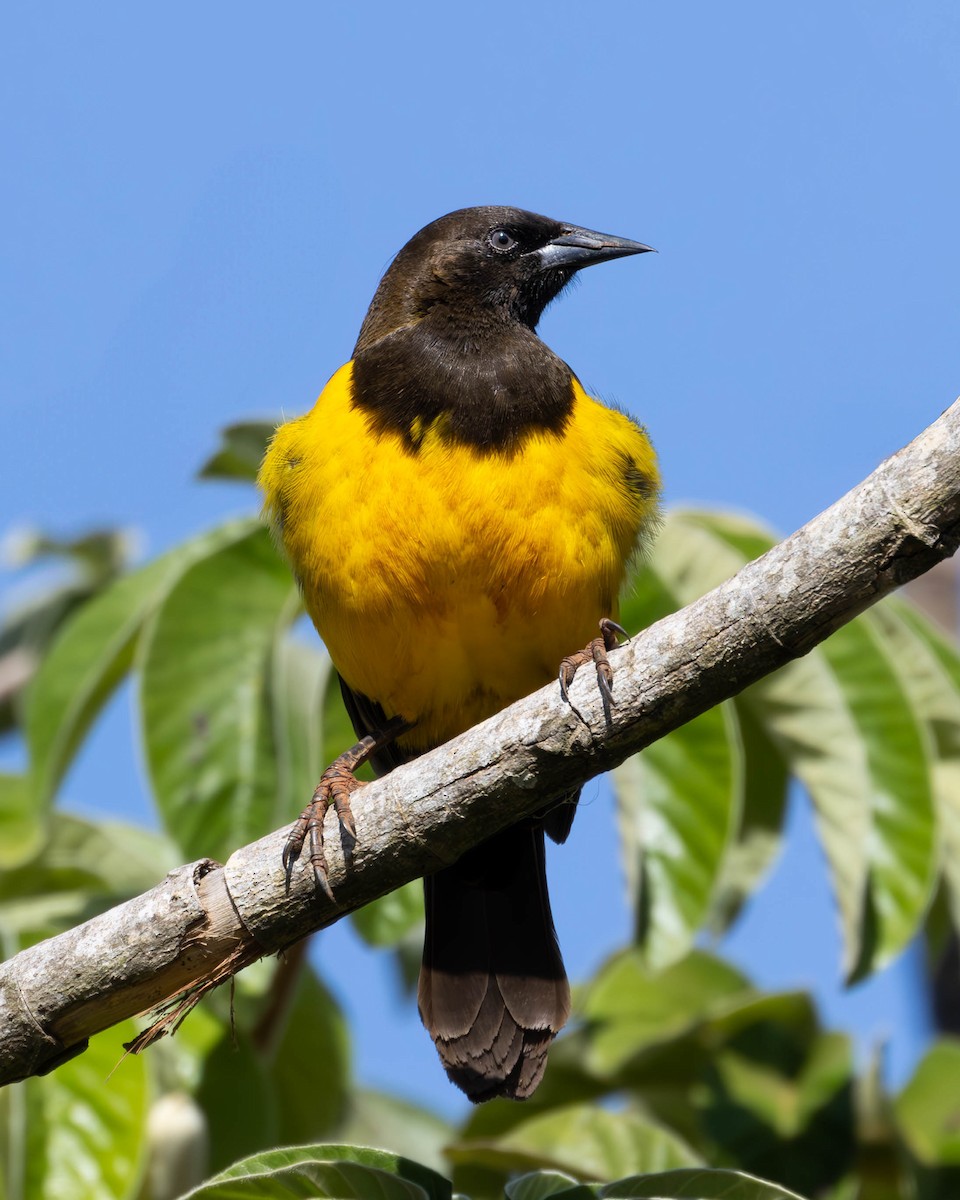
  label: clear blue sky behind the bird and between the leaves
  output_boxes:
[0,0,960,1108]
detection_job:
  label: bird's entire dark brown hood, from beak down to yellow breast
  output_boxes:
[352,208,650,452]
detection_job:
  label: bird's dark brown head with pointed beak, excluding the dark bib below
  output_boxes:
[355,205,650,353]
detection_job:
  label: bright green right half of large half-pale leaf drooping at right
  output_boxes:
[822,613,937,979]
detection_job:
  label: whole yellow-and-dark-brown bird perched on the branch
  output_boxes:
[259,205,660,1103]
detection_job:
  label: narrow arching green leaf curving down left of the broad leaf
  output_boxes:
[24,521,254,806]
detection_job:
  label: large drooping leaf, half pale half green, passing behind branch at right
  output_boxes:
[671,504,936,978]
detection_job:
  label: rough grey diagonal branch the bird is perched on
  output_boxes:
[0,401,960,1084]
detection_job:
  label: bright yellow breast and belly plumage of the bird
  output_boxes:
[259,364,658,749]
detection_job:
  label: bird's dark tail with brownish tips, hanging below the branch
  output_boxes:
[419,822,570,1103]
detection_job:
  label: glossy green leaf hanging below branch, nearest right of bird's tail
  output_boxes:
[612,704,743,967]
